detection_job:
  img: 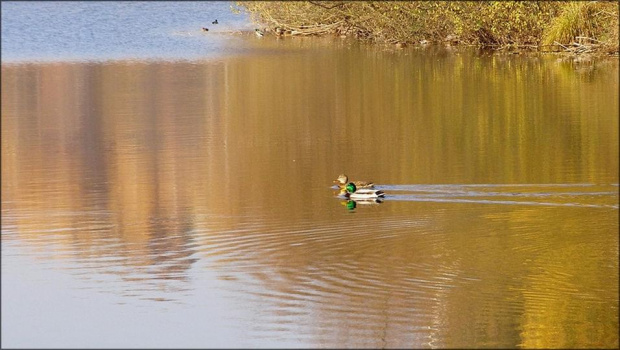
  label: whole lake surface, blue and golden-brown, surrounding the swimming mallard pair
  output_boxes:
[1,2,619,348]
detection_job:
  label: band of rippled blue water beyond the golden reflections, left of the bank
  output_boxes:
[2,1,253,63]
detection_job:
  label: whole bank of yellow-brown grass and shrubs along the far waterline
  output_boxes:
[237,1,619,55]
